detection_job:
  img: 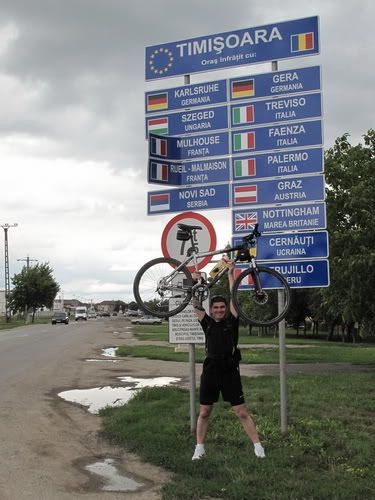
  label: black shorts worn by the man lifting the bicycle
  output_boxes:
[199,358,245,406]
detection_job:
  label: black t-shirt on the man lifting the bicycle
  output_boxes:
[200,313,238,357]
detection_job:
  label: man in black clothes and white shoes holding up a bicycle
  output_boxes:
[192,261,265,460]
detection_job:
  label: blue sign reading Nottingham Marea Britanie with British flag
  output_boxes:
[232,202,327,234]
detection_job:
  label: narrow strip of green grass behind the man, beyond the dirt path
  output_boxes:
[117,344,375,364]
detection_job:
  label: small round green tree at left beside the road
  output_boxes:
[10,263,60,322]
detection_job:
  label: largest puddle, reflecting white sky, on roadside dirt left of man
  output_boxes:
[58,377,181,414]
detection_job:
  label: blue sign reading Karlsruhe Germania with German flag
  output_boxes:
[145,80,228,114]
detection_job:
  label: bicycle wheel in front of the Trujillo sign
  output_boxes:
[232,267,290,326]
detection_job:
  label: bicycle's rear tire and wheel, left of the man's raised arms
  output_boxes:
[133,257,193,318]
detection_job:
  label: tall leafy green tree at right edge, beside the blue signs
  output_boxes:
[321,129,375,340]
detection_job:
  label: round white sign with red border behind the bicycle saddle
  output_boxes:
[161,212,216,272]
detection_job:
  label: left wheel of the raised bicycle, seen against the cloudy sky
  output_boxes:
[133,257,193,318]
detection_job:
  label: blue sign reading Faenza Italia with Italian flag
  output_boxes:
[232,120,323,154]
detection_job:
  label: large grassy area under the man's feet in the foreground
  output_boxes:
[101,373,375,500]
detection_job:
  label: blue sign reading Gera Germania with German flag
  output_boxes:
[229,66,321,101]
